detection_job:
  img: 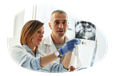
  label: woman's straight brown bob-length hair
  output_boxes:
[20,20,44,49]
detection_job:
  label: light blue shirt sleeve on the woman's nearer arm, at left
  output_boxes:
[11,46,42,70]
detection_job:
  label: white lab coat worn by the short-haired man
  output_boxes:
[39,34,82,70]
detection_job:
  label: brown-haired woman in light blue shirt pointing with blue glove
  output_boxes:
[11,20,78,73]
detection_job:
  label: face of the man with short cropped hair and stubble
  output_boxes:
[49,13,68,37]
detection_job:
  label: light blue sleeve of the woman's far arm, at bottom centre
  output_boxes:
[51,63,69,73]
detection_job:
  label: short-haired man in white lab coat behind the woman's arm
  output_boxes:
[39,10,82,72]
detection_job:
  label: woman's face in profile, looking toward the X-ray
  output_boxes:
[31,26,44,46]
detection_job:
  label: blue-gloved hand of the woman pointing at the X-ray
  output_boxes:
[59,38,81,56]
